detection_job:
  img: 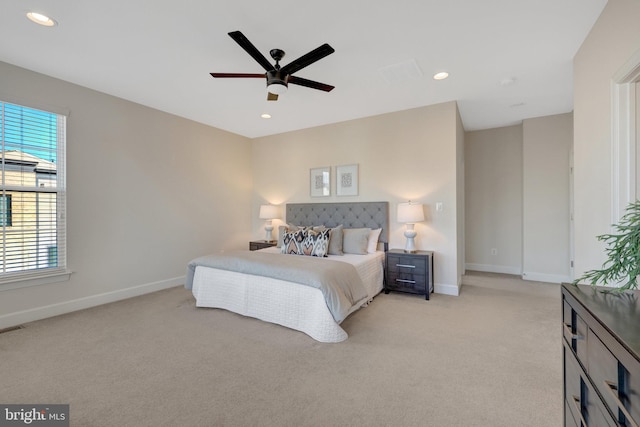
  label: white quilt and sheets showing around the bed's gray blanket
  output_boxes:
[192,247,385,342]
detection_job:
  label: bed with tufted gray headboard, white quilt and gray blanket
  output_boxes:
[185,202,389,342]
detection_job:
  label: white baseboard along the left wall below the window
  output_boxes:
[0,276,185,329]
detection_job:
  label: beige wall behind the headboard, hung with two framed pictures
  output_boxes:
[252,102,463,294]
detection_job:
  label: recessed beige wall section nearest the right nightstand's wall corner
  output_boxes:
[465,125,523,275]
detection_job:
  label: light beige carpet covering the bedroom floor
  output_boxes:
[0,273,562,427]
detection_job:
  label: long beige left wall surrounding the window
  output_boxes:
[0,62,252,327]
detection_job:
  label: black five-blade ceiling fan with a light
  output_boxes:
[210,31,335,101]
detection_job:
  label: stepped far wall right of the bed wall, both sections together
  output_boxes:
[465,113,573,283]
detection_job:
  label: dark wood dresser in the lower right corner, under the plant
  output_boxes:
[562,284,640,427]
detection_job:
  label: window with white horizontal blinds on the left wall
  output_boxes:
[0,101,66,283]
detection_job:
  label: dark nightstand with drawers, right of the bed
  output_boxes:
[384,249,433,300]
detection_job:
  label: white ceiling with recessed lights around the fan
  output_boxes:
[0,0,606,138]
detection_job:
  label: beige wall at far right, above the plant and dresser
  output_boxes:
[573,0,640,277]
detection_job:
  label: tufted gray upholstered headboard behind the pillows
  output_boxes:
[286,202,389,243]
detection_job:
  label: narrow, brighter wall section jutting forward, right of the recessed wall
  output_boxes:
[522,113,573,283]
